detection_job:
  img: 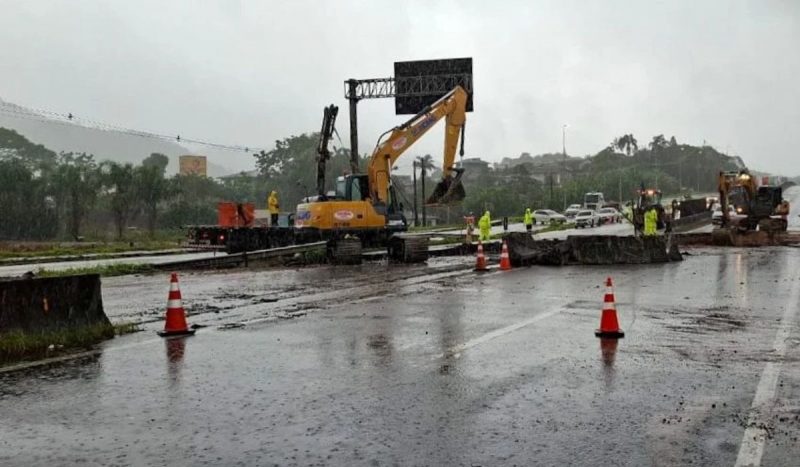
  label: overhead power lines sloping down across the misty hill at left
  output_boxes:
[0,102,267,154]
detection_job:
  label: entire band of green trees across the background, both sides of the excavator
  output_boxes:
[0,128,737,240]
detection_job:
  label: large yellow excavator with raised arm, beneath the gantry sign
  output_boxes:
[294,86,468,261]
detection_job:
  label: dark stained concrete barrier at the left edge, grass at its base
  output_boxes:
[0,274,111,333]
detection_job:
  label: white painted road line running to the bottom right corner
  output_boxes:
[735,281,800,467]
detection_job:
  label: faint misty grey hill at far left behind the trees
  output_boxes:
[0,99,233,177]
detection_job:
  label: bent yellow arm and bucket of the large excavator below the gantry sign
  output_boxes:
[367,86,467,204]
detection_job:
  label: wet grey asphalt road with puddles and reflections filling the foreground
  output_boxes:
[0,248,800,466]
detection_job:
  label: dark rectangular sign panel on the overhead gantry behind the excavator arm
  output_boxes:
[394,58,472,115]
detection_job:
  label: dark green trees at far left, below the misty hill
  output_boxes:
[0,128,250,240]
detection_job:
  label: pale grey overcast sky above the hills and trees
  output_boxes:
[0,0,800,174]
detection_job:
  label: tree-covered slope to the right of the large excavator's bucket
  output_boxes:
[454,134,741,216]
